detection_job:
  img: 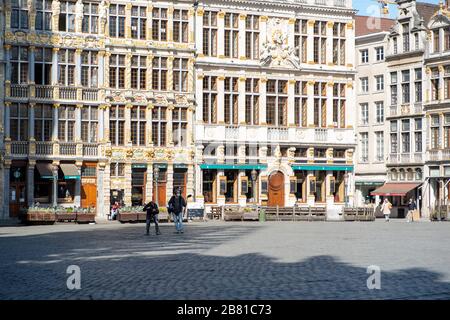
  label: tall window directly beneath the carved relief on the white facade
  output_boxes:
[266,80,288,126]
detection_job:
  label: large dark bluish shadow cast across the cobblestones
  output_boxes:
[0,224,450,300]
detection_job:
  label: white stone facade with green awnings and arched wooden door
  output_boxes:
[195,0,356,218]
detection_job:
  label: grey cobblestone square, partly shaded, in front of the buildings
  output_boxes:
[0,220,450,300]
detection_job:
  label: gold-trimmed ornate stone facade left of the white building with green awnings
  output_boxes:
[1,0,195,218]
